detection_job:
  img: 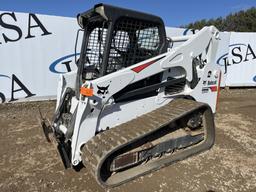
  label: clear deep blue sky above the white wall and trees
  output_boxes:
[0,0,256,27]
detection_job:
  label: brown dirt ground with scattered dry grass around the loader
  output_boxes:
[0,89,256,192]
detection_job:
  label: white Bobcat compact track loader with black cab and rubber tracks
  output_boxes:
[42,4,220,187]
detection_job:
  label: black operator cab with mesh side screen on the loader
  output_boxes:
[77,4,168,84]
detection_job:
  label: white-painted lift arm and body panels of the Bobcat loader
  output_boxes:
[57,27,220,165]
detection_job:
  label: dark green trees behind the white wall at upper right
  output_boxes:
[183,7,256,32]
